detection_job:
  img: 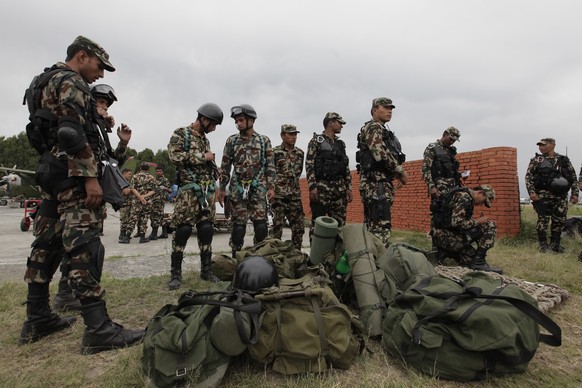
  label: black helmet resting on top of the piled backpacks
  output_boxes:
[232,256,279,293]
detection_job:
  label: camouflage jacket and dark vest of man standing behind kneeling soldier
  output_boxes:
[422,139,460,193]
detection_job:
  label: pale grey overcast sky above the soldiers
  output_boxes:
[0,0,582,196]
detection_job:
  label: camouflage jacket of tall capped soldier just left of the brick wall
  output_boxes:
[360,120,404,183]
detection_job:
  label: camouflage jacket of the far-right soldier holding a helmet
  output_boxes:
[525,153,579,199]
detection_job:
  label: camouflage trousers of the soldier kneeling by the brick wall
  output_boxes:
[432,221,497,264]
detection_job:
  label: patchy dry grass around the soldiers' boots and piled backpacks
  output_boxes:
[0,206,582,388]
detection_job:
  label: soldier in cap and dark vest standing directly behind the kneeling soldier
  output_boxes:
[422,127,461,199]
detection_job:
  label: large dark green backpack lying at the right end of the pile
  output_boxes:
[382,272,562,381]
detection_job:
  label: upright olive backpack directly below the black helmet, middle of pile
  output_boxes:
[249,267,363,375]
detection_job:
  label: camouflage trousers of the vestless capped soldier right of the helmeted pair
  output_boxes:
[271,195,305,250]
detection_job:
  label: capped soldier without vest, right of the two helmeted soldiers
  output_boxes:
[271,124,305,250]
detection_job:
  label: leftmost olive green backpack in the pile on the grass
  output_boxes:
[142,282,261,387]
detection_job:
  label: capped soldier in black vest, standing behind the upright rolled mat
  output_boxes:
[305,112,352,241]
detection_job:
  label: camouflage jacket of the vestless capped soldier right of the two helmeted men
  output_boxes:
[273,144,305,198]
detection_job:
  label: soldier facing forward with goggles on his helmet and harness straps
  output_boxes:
[218,104,275,257]
